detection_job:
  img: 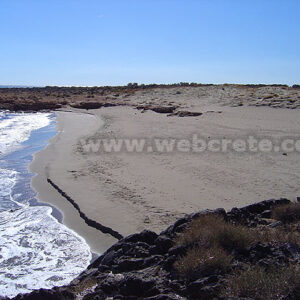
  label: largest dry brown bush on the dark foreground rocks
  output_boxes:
[174,215,256,278]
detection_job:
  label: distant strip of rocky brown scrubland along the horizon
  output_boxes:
[0,82,300,112]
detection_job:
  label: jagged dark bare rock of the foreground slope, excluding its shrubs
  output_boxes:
[10,199,300,300]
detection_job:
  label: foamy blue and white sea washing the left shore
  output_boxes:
[0,111,92,297]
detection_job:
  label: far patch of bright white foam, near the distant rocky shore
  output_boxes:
[0,113,50,156]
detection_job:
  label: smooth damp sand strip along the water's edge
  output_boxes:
[30,113,116,254]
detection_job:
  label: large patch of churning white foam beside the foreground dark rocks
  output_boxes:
[0,206,91,297]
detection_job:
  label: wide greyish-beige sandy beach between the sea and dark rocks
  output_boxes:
[32,89,300,252]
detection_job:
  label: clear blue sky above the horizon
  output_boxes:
[0,0,300,86]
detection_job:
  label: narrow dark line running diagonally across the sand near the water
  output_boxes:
[47,178,123,240]
